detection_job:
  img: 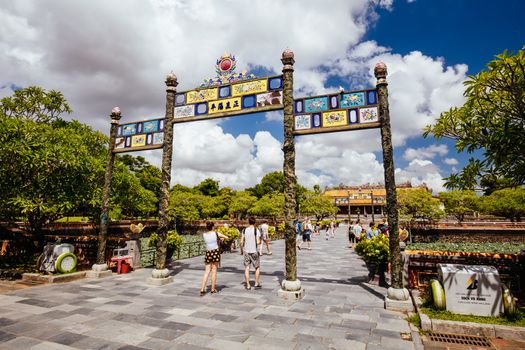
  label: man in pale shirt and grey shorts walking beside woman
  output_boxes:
[241,217,261,290]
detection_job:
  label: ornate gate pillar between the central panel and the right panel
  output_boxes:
[279,49,304,299]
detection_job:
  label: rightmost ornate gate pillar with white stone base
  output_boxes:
[374,62,412,310]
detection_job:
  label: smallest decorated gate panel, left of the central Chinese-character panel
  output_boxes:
[113,119,164,153]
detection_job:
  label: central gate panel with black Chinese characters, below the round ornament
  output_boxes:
[173,76,283,123]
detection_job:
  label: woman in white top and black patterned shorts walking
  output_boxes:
[200,221,229,296]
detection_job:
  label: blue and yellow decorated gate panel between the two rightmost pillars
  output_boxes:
[294,89,381,135]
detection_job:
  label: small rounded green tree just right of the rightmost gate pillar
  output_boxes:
[397,188,444,221]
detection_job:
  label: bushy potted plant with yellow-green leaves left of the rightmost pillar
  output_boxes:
[355,234,390,285]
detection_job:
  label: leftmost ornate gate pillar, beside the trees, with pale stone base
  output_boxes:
[87,107,121,277]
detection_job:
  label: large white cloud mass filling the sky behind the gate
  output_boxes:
[0,0,467,188]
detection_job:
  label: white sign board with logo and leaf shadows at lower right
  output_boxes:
[438,264,503,316]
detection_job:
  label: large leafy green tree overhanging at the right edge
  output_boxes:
[424,47,525,189]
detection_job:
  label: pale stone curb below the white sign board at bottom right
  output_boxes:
[410,290,525,341]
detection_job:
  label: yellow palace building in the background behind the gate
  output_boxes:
[323,182,418,217]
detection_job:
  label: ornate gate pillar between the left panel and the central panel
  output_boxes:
[148,73,179,285]
